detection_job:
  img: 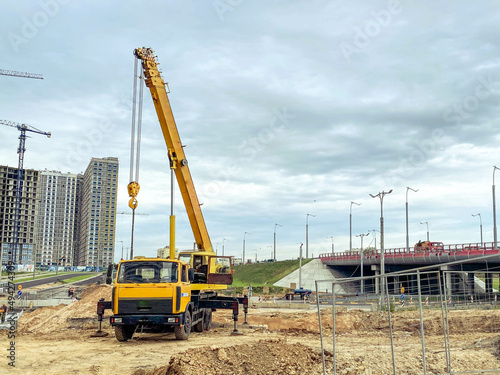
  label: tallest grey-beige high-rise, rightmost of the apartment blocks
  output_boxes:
[77,157,118,267]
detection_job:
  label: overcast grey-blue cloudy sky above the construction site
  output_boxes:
[0,0,500,259]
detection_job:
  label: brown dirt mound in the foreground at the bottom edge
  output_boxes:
[133,339,331,375]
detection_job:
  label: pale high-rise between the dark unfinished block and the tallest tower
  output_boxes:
[35,170,81,266]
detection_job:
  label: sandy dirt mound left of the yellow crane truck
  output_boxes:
[18,285,111,334]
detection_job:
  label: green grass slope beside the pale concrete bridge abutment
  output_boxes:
[232,259,312,288]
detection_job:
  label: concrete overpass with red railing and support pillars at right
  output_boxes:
[319,242,500,295]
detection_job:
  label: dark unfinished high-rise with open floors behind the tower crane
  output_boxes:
[0,166,38,265]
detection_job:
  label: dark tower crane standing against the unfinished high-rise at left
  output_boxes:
[0,120,51,264]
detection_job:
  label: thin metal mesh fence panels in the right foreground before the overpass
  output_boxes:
[311,269,500,375]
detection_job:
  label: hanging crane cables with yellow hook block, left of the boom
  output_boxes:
[127,55,144,259]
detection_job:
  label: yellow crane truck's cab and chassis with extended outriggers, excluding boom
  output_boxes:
[97,257,248,341]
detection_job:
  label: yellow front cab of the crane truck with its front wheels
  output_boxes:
[110,257,194,341]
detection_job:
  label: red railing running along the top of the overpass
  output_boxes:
[319,242,500,261]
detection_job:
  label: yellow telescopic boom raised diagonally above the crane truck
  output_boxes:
[134,48,213,252]
